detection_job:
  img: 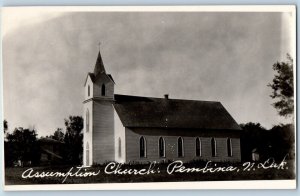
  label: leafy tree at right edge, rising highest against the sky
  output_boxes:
[268,54,294,117]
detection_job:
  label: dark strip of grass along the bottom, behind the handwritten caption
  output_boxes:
[5,161,295,185]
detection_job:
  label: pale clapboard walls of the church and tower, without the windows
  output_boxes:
[83,74,241,164]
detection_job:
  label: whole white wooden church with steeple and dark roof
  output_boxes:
[83,51,241,165]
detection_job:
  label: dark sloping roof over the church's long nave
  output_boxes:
[114,95,241,130]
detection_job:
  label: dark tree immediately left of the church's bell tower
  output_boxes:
[64,116,83,164]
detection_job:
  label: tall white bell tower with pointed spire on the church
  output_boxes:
[83,50,115,166]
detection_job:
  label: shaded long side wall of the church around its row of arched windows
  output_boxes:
[125,128,241,162]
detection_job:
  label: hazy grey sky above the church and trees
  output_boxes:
[2,7,294,136]
